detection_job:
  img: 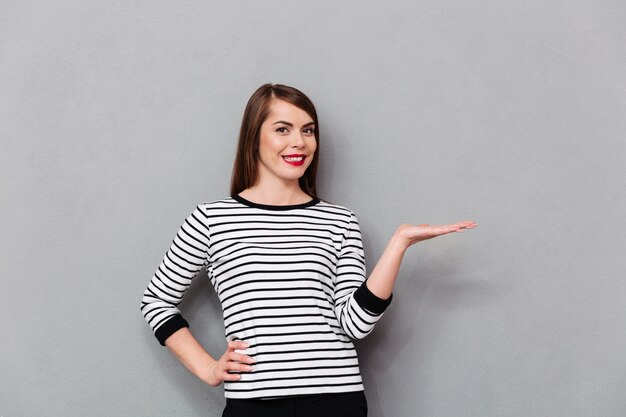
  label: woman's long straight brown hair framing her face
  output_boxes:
[230,83,320,198]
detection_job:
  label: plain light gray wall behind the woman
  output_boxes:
[0,0,626,417]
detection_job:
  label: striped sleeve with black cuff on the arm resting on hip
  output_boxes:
[141,206,210,346]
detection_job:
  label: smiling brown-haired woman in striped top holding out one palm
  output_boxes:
[141,84,476,417]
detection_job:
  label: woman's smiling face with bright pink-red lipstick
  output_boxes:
[258,99,317,183]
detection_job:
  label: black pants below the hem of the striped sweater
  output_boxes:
[222,391,367,417]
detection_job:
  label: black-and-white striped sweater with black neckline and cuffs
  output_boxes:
[141,195,391,398]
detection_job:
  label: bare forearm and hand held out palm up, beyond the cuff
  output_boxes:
[367,221,478,299]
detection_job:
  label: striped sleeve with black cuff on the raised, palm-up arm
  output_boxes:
[335,213,393,339]
